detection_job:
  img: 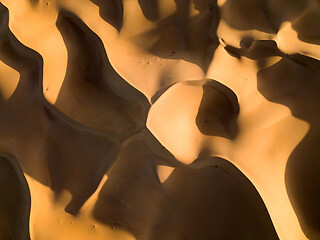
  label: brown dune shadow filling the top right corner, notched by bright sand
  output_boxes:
[221,0,320,45]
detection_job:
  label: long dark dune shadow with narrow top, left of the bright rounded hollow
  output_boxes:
[55,11,150,141]
